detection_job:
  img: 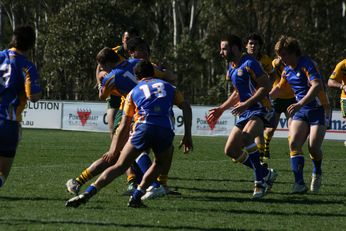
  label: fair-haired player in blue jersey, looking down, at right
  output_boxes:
[271,36,330,194]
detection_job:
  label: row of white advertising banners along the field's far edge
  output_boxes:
[23,100,346,140]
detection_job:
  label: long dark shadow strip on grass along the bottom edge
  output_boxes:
[0,218,254,231]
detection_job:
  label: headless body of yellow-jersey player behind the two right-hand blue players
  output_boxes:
[264,58,296,158]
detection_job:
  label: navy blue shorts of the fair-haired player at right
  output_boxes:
[292,106,330,126]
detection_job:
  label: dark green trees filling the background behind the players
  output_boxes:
[0,0,346,106]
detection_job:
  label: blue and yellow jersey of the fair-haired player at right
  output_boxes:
[279,56,329,109]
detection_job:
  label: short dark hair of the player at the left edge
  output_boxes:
[10,26,36,51]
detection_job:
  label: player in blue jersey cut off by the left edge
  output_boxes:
[0,26,41,188]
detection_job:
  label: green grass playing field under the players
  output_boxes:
[0,129,346,230]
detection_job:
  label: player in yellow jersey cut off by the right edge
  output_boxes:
[328,59,346,119]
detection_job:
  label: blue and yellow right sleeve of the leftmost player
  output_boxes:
[22,64,42,97]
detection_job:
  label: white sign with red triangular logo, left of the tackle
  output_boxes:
[62,102,108,132]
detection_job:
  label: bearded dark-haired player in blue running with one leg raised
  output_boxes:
[208,35,277,198]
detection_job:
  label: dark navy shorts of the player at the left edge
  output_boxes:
[0,119,20,157]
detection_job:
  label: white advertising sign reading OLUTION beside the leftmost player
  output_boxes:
[22,100,62,129]
